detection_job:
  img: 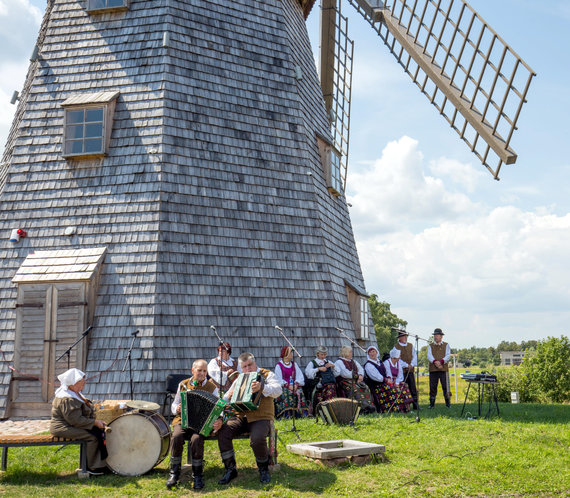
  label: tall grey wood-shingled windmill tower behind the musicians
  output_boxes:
[0,0,524,417]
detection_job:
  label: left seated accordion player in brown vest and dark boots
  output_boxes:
[166,360,222,489]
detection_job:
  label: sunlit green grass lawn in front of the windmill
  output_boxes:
[0,404,570,497]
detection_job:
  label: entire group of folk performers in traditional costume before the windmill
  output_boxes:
[50,329,450,489]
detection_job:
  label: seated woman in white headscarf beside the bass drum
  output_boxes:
[49,368,107,474]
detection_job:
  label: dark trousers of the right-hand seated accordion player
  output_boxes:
[218,417,271,463]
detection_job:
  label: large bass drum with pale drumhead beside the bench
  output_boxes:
[106,412,170,476]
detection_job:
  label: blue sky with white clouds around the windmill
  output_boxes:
[0,0,570,347]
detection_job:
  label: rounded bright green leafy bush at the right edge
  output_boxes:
[521,336,570,403]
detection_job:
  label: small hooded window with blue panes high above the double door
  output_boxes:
[62,92,119,158]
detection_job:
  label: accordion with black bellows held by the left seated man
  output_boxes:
[180,390,226,437]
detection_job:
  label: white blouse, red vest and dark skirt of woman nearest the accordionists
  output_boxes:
[275,360,312,419]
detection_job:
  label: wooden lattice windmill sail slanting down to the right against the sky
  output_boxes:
[349,0,535,180]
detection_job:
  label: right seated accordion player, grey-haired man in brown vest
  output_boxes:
[218,353,282,484]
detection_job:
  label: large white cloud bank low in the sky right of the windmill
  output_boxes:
[349,137,570,345]
